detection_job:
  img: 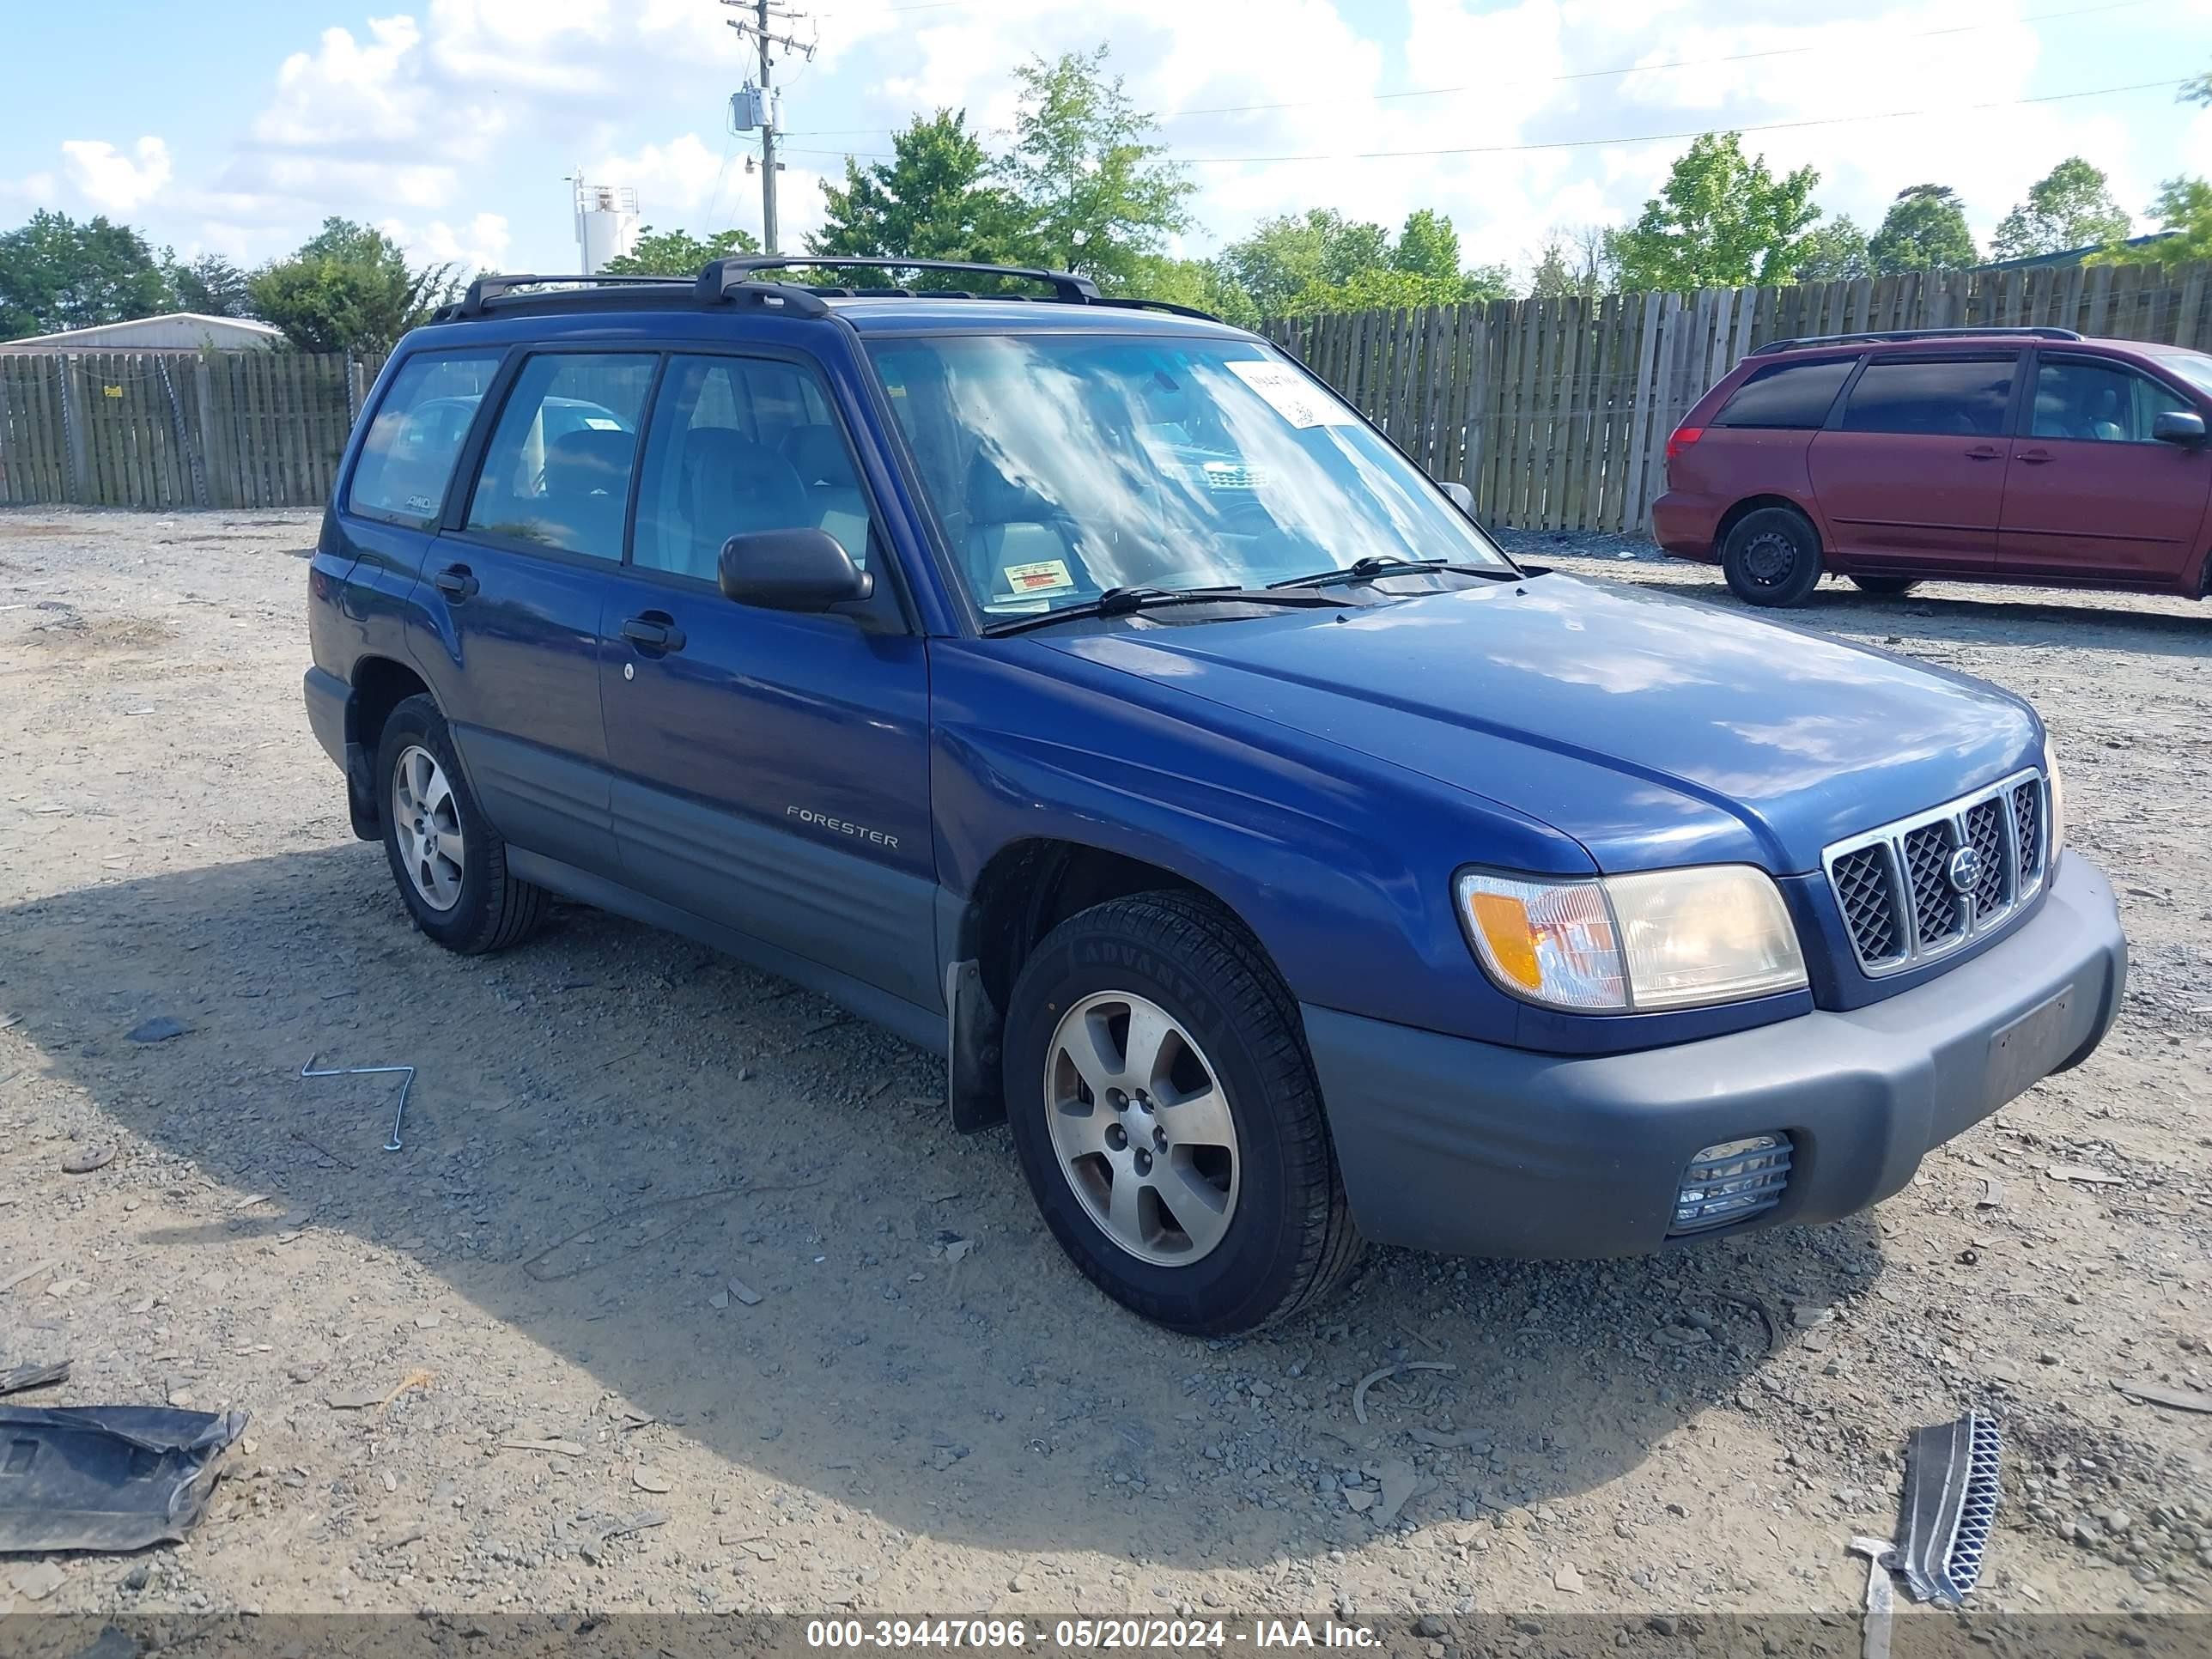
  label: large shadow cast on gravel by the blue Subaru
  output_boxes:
[0,845,1882,1566]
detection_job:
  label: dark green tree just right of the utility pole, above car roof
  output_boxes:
[807,108,1037,283]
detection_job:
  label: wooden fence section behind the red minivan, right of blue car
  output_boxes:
[1265,265,2212,533]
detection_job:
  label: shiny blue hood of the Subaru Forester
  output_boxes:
[1042,575,2042,874]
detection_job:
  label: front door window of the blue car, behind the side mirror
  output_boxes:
[630,356,869,581]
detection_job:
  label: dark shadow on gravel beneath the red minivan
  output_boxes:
[1601,568,2212,657]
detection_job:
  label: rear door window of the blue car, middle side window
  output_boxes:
[455,352,657,560]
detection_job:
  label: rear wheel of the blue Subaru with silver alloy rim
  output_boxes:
[376,696,553,956]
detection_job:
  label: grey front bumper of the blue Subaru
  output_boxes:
[1303,852,2128,1259]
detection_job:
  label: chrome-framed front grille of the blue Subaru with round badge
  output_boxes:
[1823,772,2051,975]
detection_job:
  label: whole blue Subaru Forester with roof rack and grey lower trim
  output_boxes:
[307,258,2126,1332]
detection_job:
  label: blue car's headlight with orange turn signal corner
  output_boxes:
[1453,865,1805,1013]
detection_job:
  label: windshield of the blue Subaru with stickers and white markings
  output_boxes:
[869,334,1510,615]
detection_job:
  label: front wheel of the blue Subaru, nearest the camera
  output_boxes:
[1005,894,1360,1336]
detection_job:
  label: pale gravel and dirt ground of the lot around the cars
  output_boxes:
[0,514,2212,1628]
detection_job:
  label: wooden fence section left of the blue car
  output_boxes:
[0,349,378,508]
